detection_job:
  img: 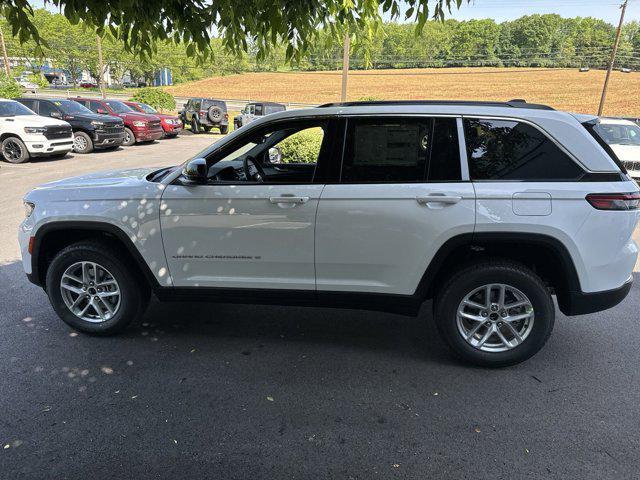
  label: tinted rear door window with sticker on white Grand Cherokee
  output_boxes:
[341,117,460,183]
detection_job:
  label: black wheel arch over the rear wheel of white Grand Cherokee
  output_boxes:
[415,232,581,312]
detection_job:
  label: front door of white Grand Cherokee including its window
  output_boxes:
[161,118,336,290]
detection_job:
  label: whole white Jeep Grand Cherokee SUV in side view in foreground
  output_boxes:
[20,101,640,366]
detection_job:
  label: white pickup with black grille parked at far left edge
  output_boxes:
[0,98,73,163]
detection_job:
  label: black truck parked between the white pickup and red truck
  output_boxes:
[16,98,125,153]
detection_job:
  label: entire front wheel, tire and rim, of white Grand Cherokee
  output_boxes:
[46,242,149,335]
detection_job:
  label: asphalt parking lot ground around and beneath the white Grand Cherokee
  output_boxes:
[0,135,640,480]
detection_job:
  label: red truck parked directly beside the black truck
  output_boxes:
[69,97,164,146]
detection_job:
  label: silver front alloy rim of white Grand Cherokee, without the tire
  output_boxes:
[60,262,121,323]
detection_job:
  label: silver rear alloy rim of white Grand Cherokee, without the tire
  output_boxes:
[457,283,535,352]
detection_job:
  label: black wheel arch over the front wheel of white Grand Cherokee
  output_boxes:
[31,221,159,288]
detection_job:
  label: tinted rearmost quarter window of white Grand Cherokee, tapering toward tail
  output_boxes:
[464,119,583,180]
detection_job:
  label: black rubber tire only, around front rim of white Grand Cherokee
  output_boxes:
[46,241,149,335]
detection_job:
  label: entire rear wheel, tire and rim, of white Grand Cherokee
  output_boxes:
[435,260,555,367]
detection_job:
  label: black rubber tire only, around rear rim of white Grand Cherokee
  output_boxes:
[434,259,555,367]
